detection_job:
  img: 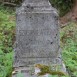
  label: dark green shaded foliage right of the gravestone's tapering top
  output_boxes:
[50,0,74,16]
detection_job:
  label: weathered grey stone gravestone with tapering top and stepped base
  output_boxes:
[12,0,66,77]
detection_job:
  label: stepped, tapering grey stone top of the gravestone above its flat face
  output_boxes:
[16,0,58,16]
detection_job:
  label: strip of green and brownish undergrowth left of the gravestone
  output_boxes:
[0,6,15,77]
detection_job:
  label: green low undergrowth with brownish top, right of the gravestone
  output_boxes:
[60,22,77,77]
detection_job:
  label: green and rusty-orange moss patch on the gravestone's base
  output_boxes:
[34,64,67,76]
